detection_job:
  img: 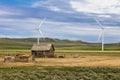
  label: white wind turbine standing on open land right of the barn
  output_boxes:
[95,18,105,51]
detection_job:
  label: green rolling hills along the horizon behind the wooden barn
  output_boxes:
[0,38,120,50]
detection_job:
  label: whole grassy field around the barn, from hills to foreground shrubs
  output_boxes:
[0,50,120,67]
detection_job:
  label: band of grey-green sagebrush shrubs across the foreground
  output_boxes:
[0,67,120,80]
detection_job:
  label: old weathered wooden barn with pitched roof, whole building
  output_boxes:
[31,44,55,58]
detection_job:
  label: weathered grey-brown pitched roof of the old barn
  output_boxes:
[31,44,54,51]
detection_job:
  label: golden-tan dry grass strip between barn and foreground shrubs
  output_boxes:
[0,56,120,67]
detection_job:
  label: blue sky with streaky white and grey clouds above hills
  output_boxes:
[0,0,120,43]
